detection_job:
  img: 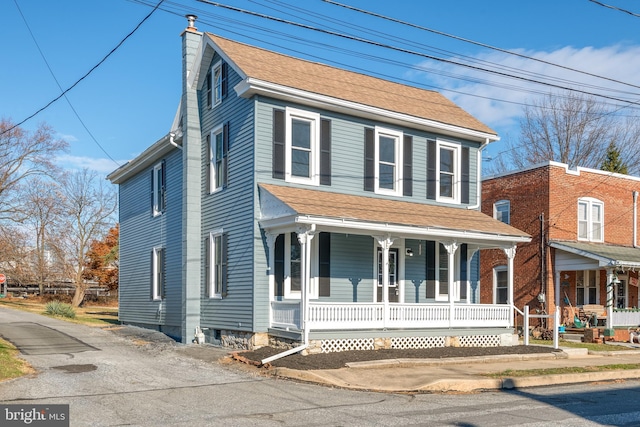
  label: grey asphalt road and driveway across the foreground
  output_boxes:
[0,308,640,427]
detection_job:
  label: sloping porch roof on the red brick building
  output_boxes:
[549,240,640,269]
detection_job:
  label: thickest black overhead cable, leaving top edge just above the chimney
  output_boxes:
[198,0,640,105]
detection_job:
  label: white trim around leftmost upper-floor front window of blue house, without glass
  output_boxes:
[285,107,320,185]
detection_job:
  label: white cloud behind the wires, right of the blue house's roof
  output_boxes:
[411,45,640,133]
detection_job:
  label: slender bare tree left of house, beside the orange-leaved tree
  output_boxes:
[57,169,117,307]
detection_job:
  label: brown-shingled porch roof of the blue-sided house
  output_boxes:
[259,184,531,246]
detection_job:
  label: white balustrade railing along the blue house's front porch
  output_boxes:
[271,301,511,330]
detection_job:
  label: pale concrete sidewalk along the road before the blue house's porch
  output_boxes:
[266,347,640,393]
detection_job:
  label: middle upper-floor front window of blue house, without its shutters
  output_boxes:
[375,127,402,195]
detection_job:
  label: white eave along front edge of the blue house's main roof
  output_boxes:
[234,77,500,143]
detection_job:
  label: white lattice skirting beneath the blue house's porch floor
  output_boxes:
[320,335,501,353]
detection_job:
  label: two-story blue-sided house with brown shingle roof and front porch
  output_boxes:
[109,17,529,351]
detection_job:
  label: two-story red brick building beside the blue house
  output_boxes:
[480,162,640,330]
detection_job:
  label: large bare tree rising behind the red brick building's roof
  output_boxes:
[488,92,640,173]
